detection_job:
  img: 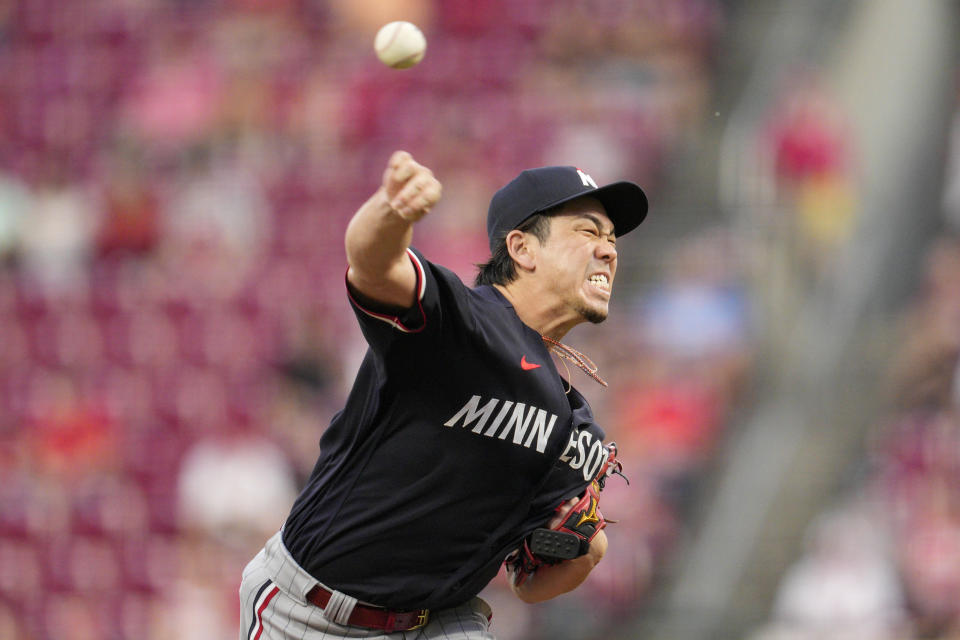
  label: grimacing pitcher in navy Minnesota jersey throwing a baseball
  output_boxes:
[240,151,647,640]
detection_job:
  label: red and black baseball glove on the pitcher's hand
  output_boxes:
[505,442,629,586]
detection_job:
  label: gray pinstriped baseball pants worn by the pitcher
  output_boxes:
[240,533,496,640]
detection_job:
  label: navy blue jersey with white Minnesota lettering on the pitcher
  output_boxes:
[283,246,606,609]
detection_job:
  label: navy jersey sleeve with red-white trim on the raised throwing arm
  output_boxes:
[347,249,467,354]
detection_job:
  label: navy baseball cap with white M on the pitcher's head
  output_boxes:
[487,167,647,253]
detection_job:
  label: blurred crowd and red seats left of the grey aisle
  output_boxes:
[0,0,752,640]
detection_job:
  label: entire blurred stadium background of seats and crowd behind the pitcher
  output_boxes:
[0,0,960,640]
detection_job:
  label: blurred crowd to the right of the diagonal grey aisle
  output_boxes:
[751,87,960,640]
